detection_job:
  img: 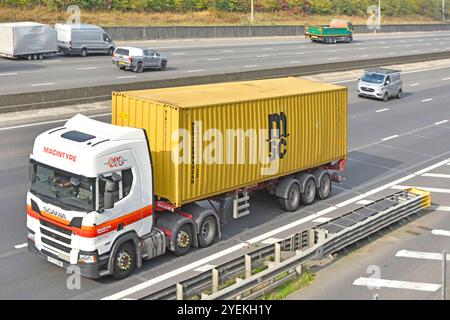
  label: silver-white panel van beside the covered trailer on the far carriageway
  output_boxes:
[55,23,115,57]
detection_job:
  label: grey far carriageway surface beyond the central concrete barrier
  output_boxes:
[0,31,450,95]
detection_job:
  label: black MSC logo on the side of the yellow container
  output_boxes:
[267,112,289,161]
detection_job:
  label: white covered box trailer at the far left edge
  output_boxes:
[0,22,58,60]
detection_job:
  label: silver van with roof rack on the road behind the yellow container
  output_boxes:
[357,68,403,101]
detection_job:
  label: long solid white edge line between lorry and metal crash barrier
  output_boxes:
[102,159,450,300]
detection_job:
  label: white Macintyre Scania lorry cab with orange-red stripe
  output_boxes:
[27,115,165,278]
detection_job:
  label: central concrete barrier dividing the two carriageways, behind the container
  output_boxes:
[0,51,450,113]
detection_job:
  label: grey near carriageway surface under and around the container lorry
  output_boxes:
[0,65,450,299]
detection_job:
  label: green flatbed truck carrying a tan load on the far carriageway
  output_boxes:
[305,19,353,44]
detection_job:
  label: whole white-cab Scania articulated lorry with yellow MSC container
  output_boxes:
[27,78,347,279]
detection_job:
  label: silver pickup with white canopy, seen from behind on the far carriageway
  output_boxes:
[112,47,167,73]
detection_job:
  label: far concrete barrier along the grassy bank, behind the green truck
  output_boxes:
[104,24,450,41]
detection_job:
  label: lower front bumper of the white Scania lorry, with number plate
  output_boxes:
[28,239,109,279]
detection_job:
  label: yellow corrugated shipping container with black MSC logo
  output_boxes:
[112,78,347,207]
